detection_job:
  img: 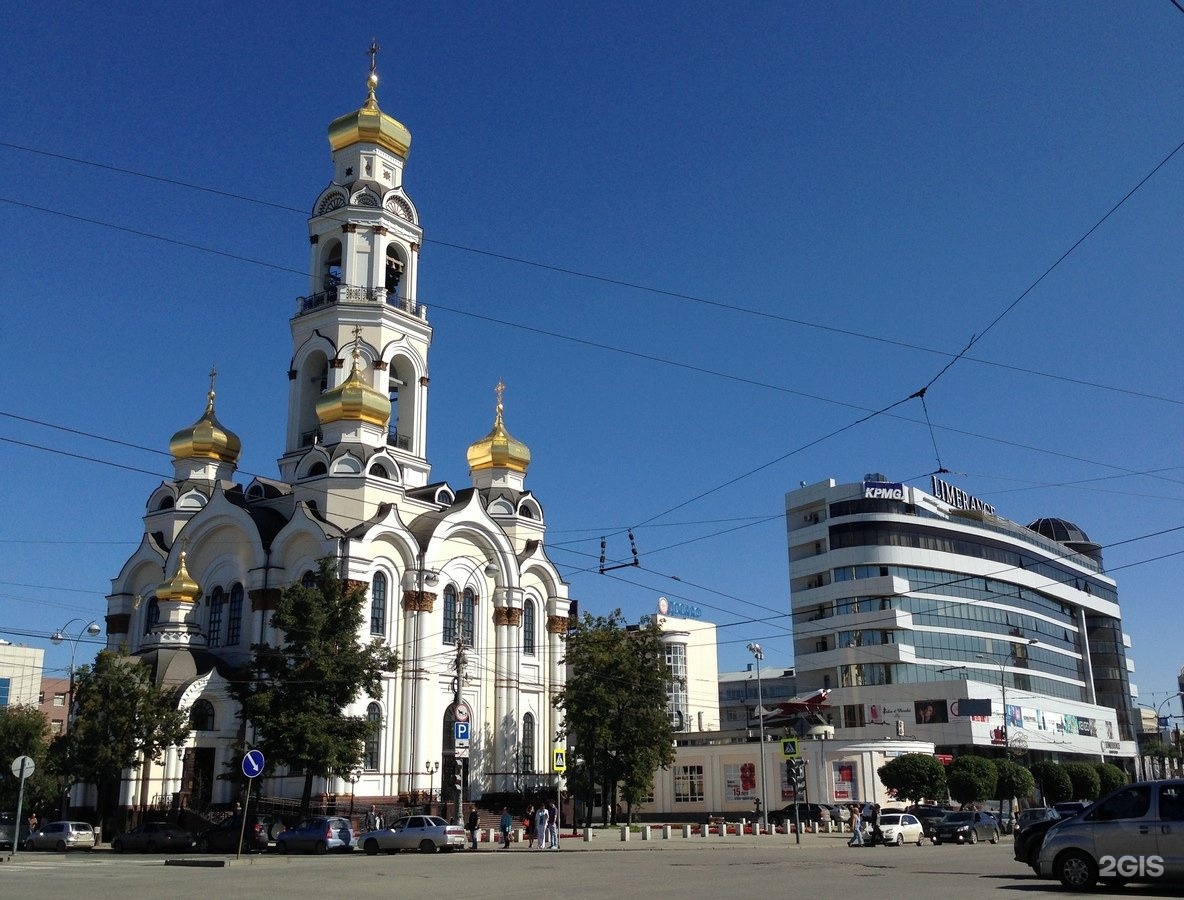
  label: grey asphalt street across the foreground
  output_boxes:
[0,833,1180,900]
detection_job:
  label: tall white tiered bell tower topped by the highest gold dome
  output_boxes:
[279,44,432,488]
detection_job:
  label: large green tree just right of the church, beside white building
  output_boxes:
[554,610,675,824]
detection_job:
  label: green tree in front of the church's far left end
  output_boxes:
[53,650,189,830]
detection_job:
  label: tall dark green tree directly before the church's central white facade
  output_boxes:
[236,559,399,815]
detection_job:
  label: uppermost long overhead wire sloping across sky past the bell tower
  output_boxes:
[0,141,1184,406]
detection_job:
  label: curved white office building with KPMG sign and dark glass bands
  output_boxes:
[785,474,1135,763]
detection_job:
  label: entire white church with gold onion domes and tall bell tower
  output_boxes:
[99,49,570,806]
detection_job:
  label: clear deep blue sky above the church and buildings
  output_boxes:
[0,0,1184,705]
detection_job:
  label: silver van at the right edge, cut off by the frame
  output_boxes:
[1036,779,1184,891]
